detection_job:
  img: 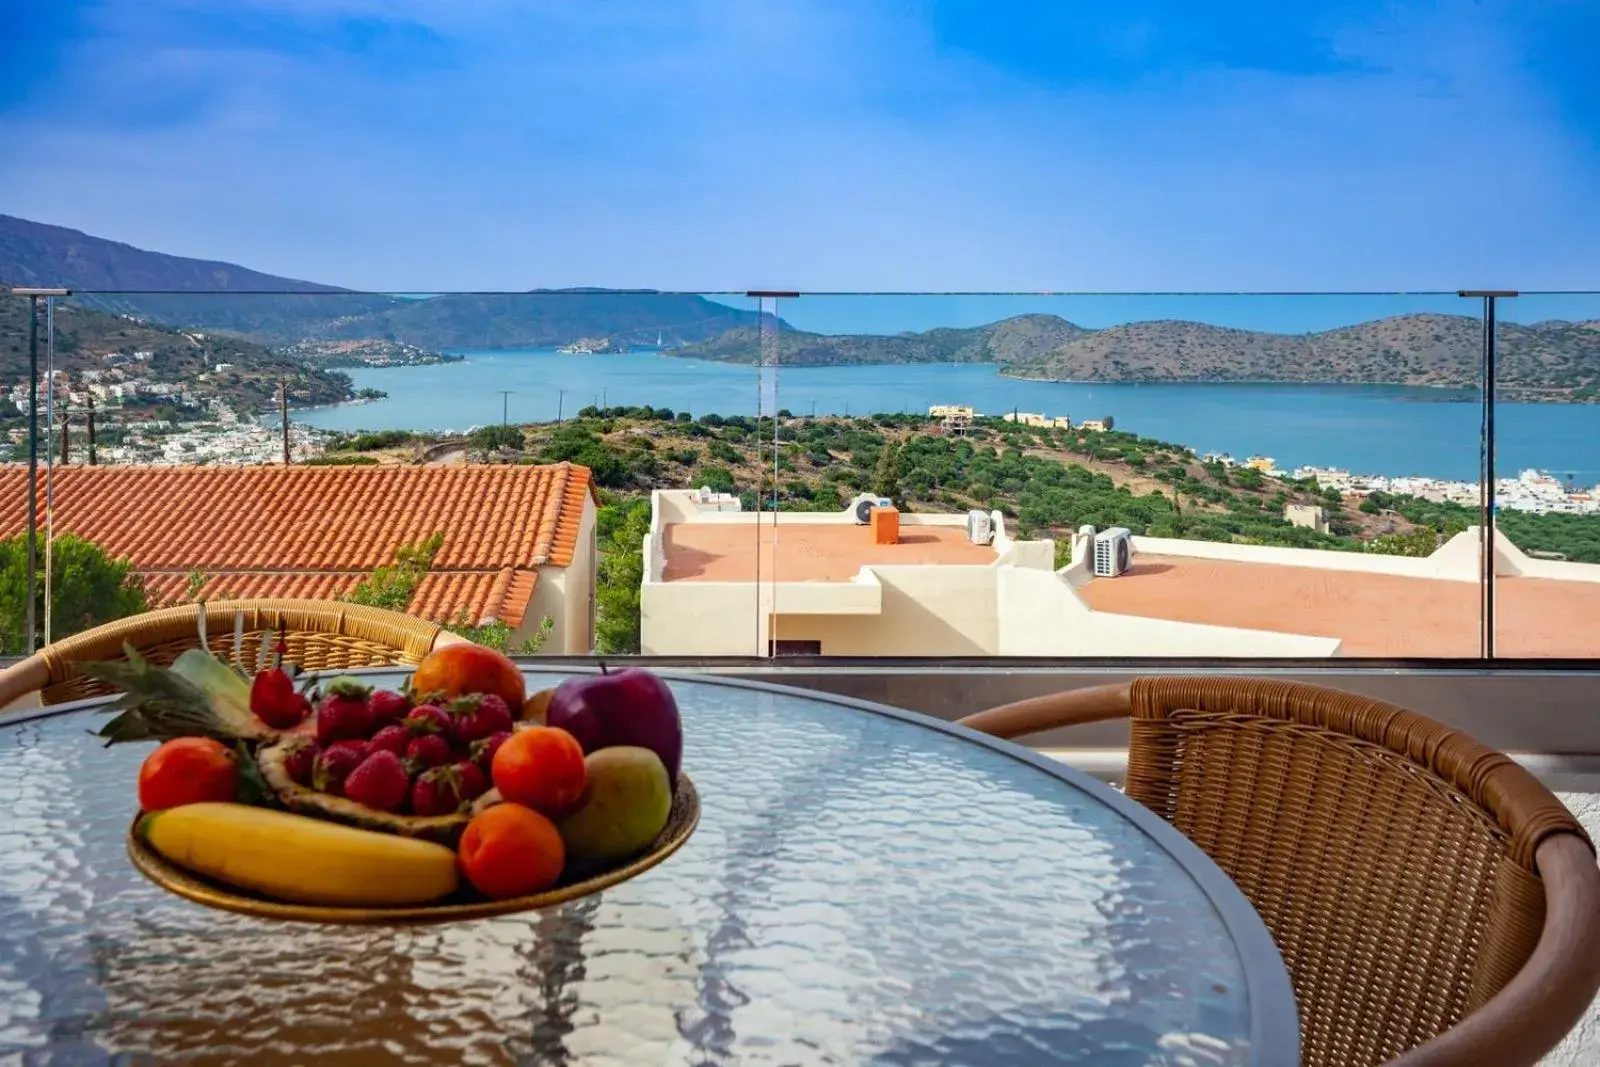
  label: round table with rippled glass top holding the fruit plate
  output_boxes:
[0,670,1299,1067]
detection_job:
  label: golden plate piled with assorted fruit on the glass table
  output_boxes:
[82,633,699,923]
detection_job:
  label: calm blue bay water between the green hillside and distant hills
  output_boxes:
[294,350,1600,485]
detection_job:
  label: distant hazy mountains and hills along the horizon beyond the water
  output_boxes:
[0,216,1600,398]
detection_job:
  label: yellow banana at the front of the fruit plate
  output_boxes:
[139,803,458,907]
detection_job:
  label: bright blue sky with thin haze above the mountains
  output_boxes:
[0,0,1600,328]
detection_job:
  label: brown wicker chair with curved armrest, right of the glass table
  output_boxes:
[962,677,1600,1067]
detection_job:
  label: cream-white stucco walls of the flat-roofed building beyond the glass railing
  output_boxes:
[640,490,1363,657]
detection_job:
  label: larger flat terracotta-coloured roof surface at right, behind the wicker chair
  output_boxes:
[1078,555,1600,657]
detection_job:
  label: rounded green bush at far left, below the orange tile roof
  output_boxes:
[0,534,150,656]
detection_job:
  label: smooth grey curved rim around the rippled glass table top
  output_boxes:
[0,664,1299,1067]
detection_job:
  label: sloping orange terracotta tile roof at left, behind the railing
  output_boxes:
[0,464,594,625]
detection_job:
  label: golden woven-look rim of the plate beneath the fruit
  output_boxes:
[128,774,699,925]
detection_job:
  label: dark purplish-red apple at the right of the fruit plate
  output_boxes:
[544,667,683,789]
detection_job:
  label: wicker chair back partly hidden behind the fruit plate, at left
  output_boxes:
[0,600,466,709]
